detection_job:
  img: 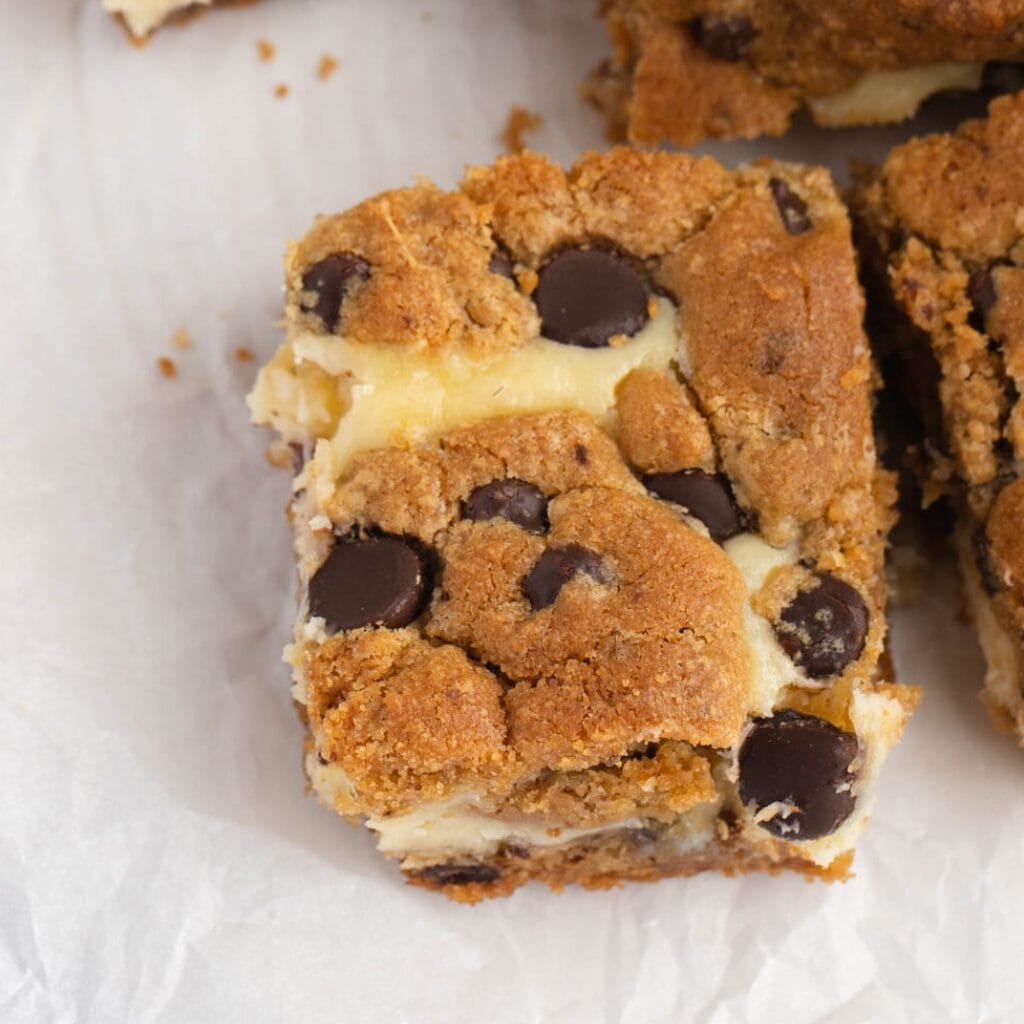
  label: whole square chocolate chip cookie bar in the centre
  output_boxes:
[250,150,916,901]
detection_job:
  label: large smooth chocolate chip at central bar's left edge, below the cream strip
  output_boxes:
[309,537,427,633]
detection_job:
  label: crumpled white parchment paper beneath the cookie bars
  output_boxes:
[0,0,1024,1024]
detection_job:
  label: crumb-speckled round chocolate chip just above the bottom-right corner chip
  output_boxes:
[775,572,868,679]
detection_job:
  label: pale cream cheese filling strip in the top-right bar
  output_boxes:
[808,62,984,128]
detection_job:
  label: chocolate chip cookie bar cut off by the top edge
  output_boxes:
[585,0,1024,145]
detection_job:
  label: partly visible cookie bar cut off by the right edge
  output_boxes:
[854,93,1024,740]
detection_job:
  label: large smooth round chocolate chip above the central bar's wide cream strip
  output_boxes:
[534,249,647,348]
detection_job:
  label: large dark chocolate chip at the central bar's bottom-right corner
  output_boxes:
[739,711,858,841]
